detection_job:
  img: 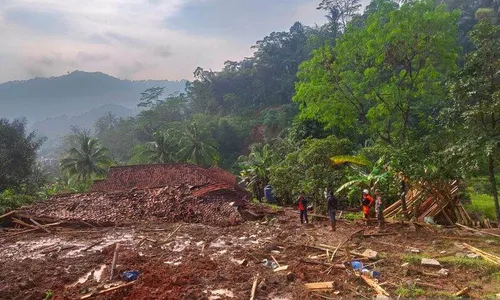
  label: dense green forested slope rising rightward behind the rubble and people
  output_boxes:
[2,0,500,223]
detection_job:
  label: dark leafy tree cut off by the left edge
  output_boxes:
[0,119,45,193]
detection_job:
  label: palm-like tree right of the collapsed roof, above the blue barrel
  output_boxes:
[239,144,272,201]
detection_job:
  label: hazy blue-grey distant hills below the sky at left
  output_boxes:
[0,71,186,123]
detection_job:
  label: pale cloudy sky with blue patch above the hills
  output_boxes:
[0,0,367,82]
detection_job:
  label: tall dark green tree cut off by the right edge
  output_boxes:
[452,9,500,225]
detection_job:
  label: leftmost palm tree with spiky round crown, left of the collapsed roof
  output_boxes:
[60,134,111,181]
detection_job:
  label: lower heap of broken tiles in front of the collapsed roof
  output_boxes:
[22,185,243,226]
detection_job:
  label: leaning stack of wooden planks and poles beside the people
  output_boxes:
[384,180,474,225]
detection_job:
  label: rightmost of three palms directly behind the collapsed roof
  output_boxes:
[179,123,219,166]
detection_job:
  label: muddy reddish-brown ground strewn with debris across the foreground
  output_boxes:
[0,210,500,300]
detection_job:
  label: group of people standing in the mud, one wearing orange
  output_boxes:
[298,189,384,231]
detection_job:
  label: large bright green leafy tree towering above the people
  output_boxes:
[294,0,459,175]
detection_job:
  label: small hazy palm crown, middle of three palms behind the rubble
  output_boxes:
[141,131,176,164]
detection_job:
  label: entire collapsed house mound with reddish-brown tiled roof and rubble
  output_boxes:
[9,164,254,226]
